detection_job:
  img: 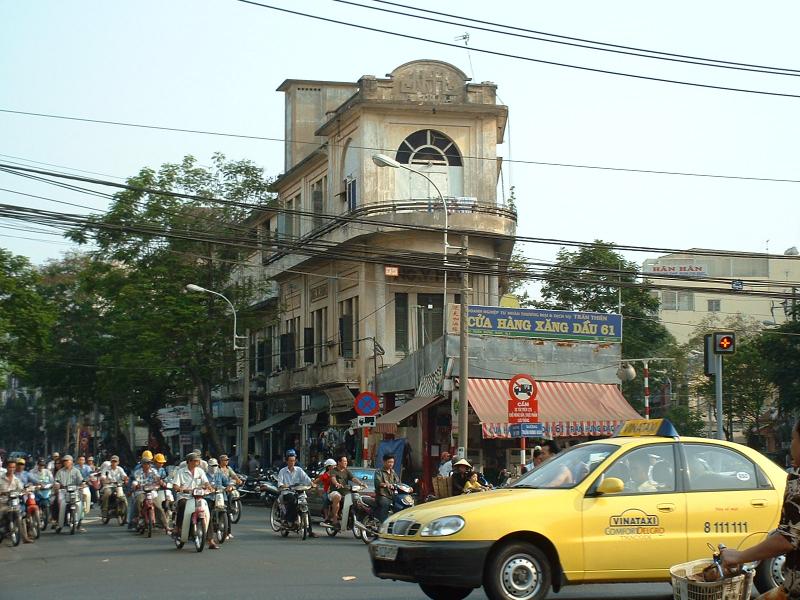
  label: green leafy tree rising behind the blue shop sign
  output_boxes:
[535,240,676,405]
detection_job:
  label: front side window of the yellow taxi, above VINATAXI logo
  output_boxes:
[603,444,675,494]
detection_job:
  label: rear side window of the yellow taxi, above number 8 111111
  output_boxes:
[683,444,758,491]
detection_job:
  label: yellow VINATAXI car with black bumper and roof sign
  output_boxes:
[369,420,786,600]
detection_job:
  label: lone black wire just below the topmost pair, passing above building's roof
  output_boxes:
[237,0,800,98]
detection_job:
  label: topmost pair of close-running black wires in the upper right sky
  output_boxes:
[333,0,800,77]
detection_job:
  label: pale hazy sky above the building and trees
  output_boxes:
[0,0,800,264]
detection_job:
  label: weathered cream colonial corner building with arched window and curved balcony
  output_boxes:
[244,60,516,460]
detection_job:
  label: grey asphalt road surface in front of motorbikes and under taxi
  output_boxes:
[0,506,672,600]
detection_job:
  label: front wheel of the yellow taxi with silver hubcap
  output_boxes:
[483,542,552,600]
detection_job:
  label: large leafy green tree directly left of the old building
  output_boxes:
[65,154,272,452]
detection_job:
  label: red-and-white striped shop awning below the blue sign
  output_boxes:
[460,378,641,437]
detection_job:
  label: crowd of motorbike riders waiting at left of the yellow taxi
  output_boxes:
[0,450,484,551]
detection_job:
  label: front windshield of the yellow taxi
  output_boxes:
[510,444,619,489]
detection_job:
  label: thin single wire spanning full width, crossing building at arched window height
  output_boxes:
[0,110,800,183]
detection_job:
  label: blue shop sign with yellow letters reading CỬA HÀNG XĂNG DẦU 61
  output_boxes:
[449,304,622,343]
